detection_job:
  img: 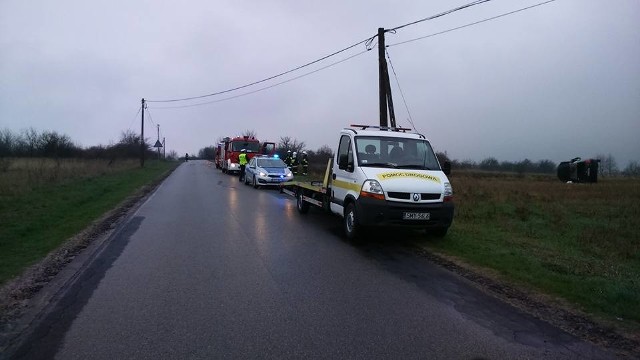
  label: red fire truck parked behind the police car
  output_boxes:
[215,136,276,173]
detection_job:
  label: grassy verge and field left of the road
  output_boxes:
[0,161,177,285]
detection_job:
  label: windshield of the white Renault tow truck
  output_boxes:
[355,136,440,170]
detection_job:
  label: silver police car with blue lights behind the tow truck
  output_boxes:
[244,156,293,189]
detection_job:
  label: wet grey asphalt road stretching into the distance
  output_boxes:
[10,161,613,359]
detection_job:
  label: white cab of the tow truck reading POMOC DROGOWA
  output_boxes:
[330,125,454,237]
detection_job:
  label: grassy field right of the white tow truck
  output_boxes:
[425,174,640,329]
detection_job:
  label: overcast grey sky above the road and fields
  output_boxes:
[0,0,640,168]
